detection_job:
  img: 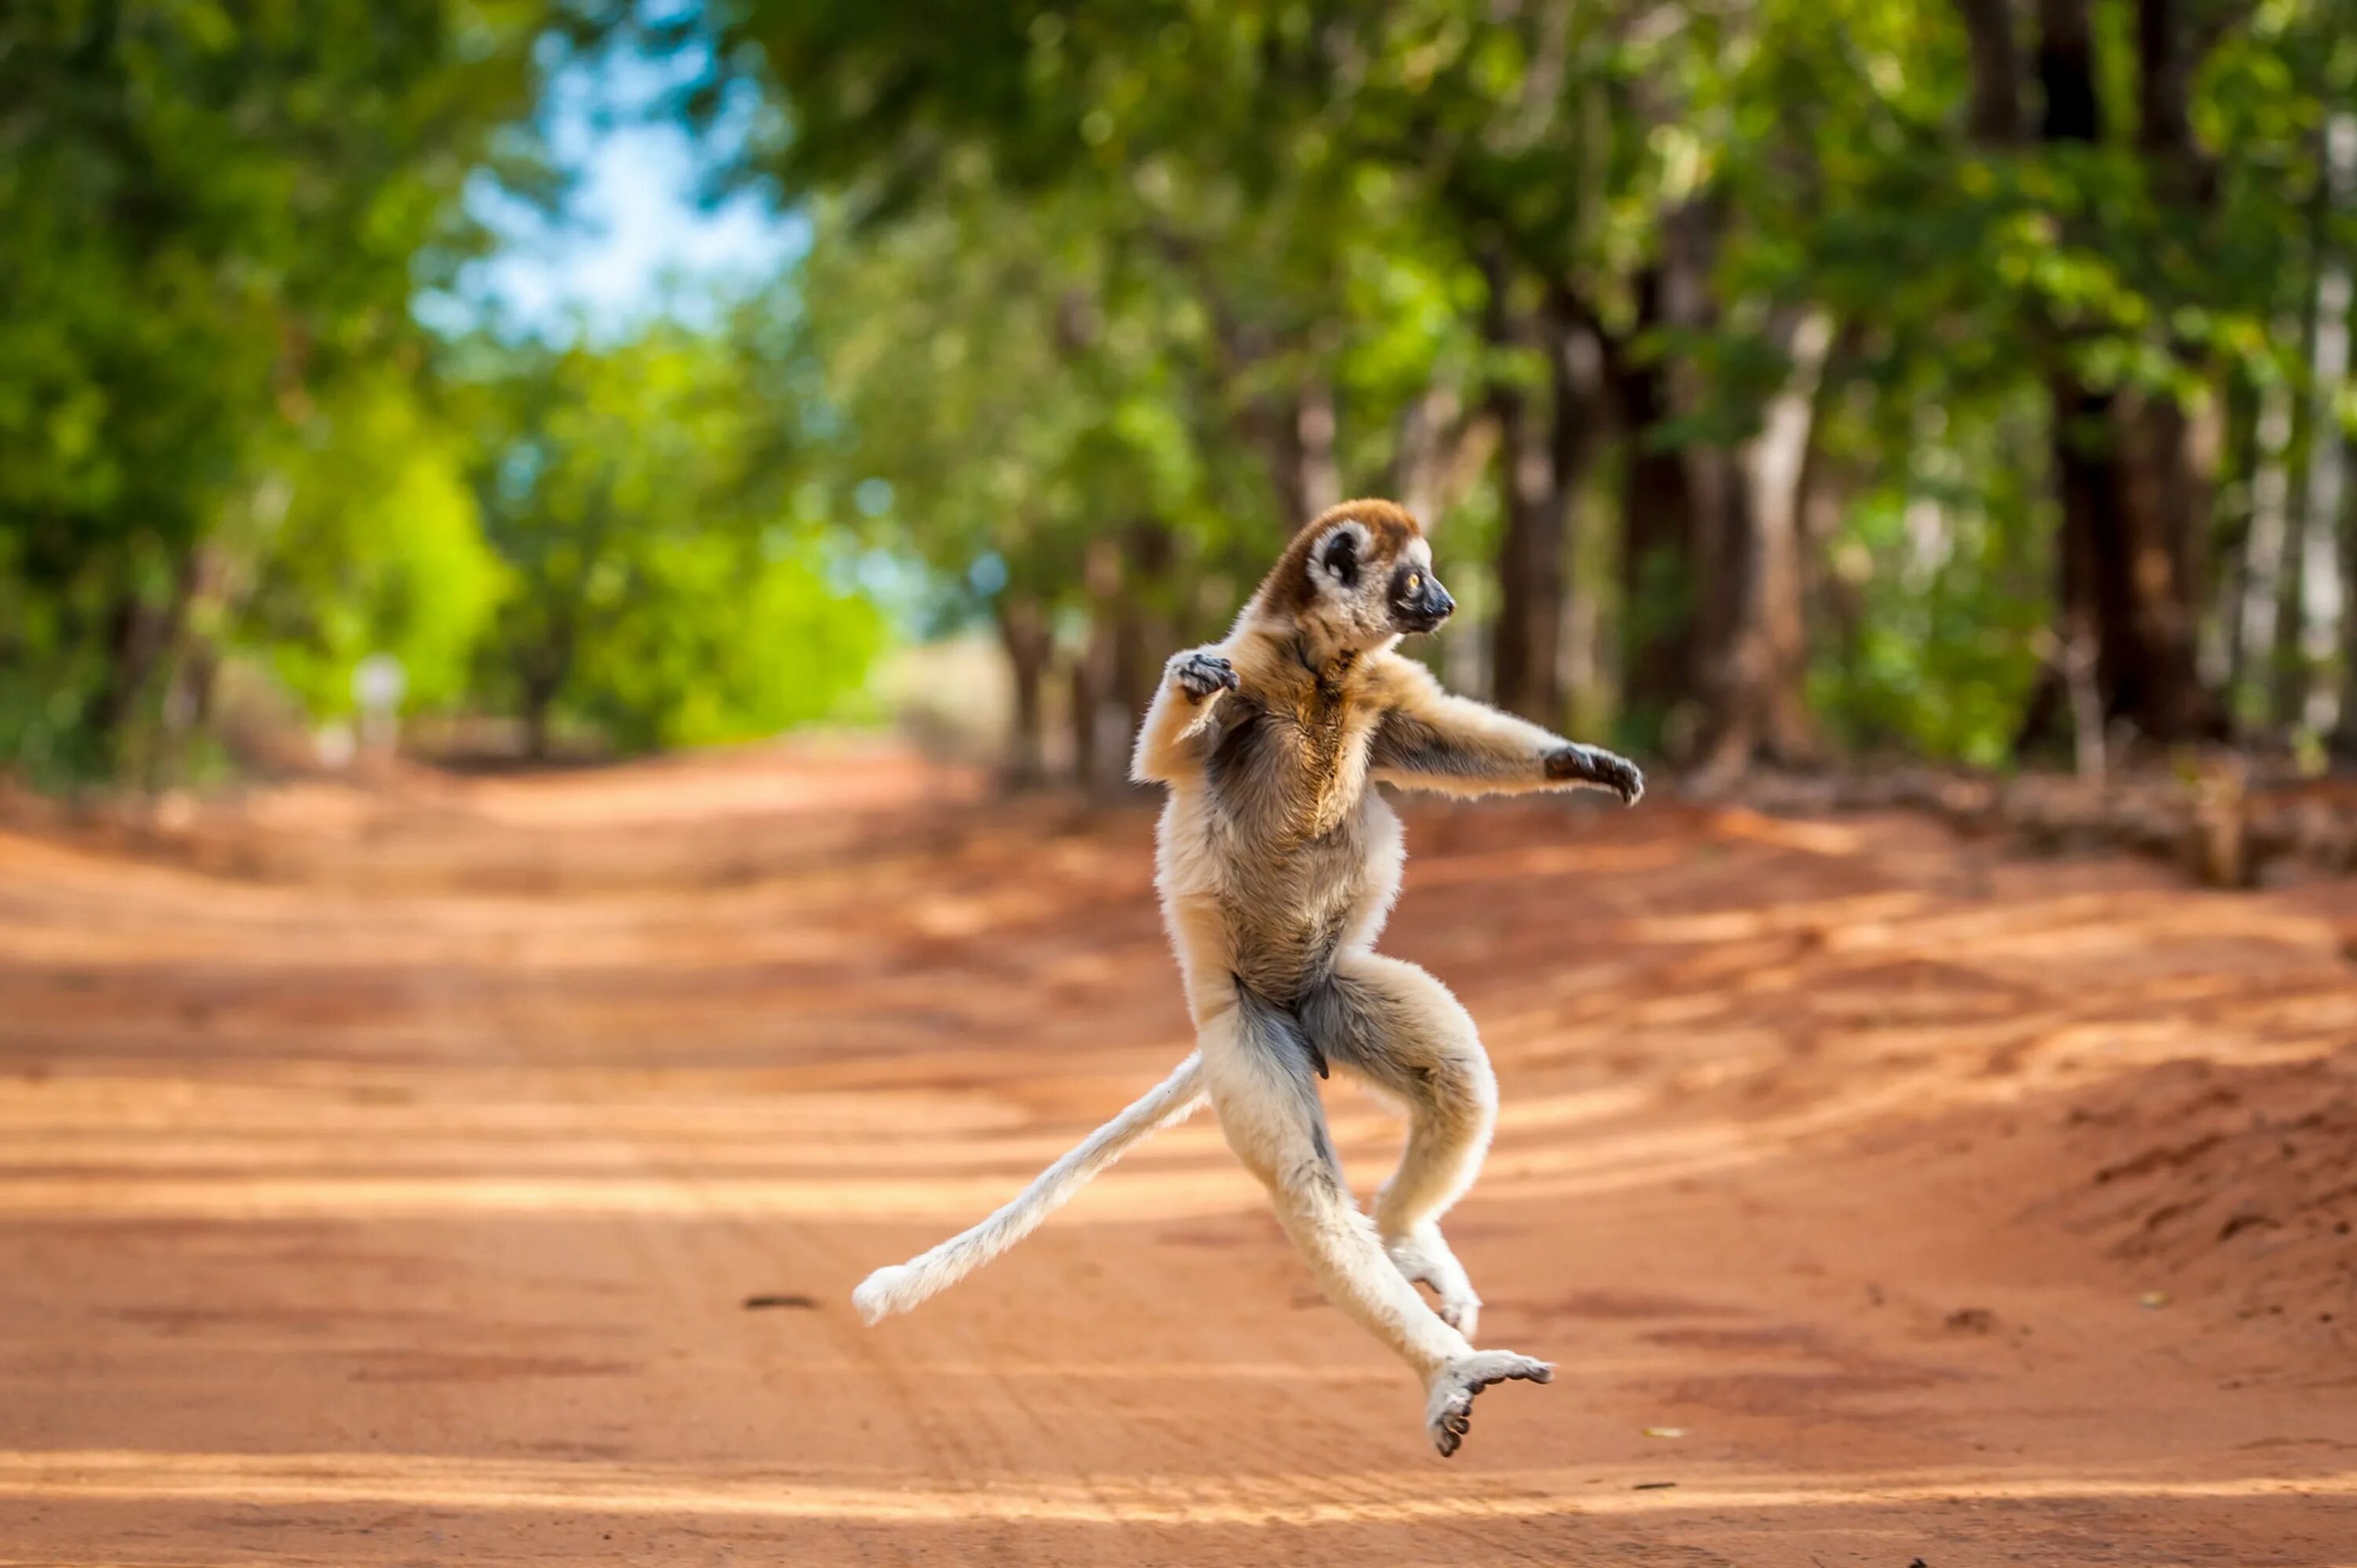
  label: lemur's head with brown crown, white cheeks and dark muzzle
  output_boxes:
[1256,500,1457,650]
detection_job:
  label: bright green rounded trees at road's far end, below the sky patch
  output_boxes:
[457,325,884,754]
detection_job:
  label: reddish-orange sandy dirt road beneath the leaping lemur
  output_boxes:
[0,752,2357,1568]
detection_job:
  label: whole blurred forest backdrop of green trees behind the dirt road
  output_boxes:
[0,0,2357,790]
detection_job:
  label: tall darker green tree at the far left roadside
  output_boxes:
[0,0,618,778]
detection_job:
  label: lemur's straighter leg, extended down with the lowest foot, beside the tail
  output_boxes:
[1202,1000,1553,1455]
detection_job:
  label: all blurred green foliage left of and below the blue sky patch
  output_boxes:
[0,0,882,786]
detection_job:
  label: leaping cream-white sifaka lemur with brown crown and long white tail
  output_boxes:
[853,500,1645,1455]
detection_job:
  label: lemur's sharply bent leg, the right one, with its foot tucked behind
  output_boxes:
[1301,951,1497,1337]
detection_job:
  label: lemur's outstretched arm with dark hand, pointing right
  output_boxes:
[1367,658,1645,807]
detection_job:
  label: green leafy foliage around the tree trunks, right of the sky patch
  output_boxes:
[721,0,2357,761]
